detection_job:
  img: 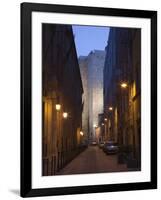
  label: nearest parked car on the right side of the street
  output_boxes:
[102,141,119,154]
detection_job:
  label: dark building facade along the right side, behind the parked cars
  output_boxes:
[104,28,141,166]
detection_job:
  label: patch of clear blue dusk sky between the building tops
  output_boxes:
[72,25,109,57]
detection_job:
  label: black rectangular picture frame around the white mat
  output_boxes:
[21,3,157,197]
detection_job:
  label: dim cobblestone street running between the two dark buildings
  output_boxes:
[57,146,128,175]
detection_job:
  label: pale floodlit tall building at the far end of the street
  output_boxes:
[79,50,105,140]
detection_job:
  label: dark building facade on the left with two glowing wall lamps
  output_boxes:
[42,24,83,176]
